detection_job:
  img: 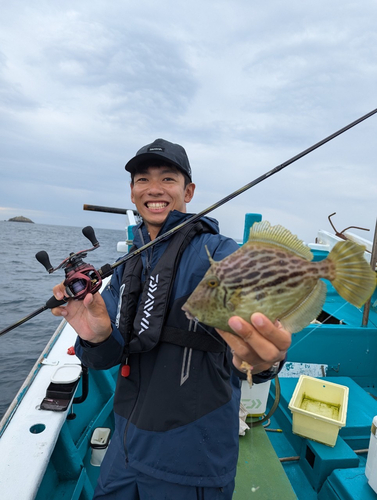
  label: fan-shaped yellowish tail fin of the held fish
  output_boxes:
[327,240,376,307]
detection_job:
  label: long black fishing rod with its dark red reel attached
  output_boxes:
[0,108,377,336]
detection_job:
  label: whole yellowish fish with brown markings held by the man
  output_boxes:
[182,221,376,333]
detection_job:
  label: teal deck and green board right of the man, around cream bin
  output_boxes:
[234,377,377,500]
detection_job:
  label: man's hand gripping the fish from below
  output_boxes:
[217,313,291,374]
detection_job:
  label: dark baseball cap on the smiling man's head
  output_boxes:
[125,139,192,181]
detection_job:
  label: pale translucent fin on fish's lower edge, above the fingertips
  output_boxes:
[279,280,327,333]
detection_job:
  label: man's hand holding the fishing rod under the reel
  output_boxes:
[51,283,112,343]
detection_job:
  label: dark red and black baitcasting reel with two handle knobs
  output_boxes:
[35,226,102,300]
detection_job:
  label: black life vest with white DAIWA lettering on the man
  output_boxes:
[117,221,226,360]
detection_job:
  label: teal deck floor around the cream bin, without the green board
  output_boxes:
[254,377,377,500]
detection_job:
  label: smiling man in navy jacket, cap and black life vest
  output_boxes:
[53,139,290,500]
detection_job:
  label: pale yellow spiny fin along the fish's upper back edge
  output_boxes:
[248,221,313,260]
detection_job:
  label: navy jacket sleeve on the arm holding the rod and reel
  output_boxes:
[75,266,124,370]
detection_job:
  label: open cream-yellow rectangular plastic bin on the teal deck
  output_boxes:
[288,375,349,446]
